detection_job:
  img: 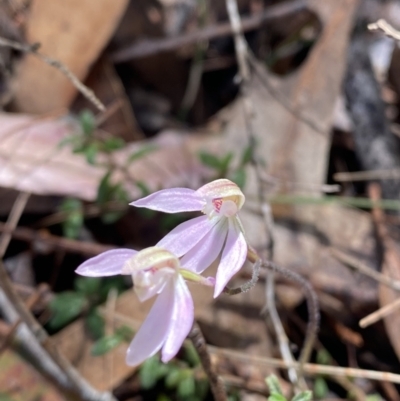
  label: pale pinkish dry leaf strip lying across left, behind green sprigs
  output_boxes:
[0,113,215,201]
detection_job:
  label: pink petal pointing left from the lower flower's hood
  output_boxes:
[75,249,137,277]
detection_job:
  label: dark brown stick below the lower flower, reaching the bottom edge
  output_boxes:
[189,322,228,401]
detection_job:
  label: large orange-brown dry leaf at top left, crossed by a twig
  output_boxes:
[11,0,128,113]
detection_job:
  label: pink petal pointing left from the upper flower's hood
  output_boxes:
[130,188,205,213]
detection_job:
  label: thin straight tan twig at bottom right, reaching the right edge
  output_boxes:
[208,345,400,384]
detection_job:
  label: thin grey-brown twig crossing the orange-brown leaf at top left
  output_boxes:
[0,37,106,111]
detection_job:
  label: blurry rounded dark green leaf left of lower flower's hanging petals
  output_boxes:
[49,291,87,330]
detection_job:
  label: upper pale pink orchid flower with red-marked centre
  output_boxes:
[131,179,247,297]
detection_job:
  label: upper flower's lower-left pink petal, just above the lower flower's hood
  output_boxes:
[157,216,219,258]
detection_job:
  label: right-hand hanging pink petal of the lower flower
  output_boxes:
[161,275,194,363]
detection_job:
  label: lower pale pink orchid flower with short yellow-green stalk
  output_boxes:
[76,247,215,366]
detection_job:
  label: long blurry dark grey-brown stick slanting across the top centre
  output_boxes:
[111,0,307,63]
